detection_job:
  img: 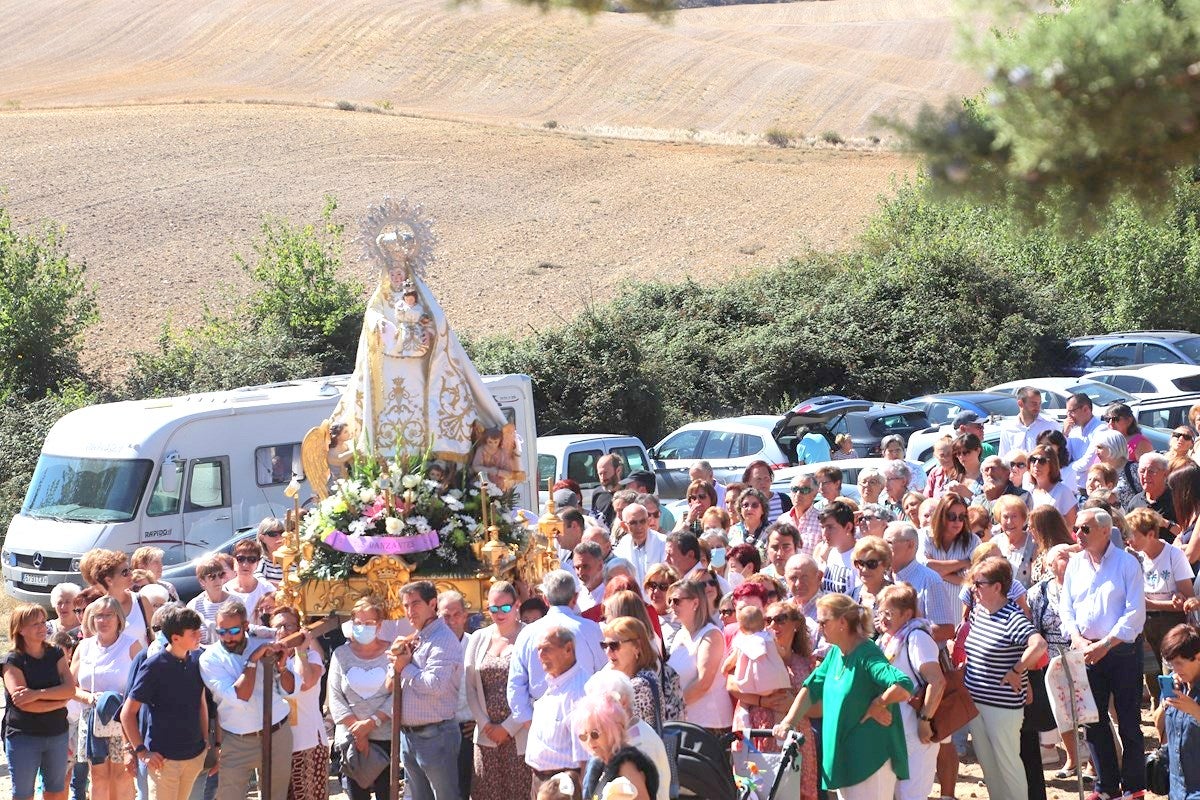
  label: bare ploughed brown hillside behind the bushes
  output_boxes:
[0,0,976,369]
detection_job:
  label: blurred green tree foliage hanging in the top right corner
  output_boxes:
[893,0,1200,226]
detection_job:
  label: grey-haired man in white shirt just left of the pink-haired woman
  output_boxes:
[526,625,592,800]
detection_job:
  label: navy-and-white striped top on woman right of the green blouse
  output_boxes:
[964,600,1037,709]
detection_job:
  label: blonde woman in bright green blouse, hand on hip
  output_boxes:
[775,595,913,800]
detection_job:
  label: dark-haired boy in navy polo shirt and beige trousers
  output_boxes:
[121,608,209,800]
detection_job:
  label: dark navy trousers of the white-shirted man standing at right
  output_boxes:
[1085,636,1146,795]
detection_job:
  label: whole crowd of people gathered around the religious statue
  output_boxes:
[4,389,1200,800]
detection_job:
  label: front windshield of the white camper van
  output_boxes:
[20,453,154,522]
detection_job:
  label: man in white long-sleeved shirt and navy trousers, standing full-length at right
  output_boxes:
[1058,509,1146,798]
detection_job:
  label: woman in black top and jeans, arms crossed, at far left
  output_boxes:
[2,603,76,800]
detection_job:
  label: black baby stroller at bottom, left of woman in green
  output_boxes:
[664,722,804,800]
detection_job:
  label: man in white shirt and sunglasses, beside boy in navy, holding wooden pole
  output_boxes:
[200,600,296,800]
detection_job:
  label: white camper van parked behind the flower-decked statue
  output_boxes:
[0,375,538,606]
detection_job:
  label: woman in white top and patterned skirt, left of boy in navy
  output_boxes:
[71,595,142,800]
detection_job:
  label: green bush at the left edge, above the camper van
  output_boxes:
[0,207,97,399]
